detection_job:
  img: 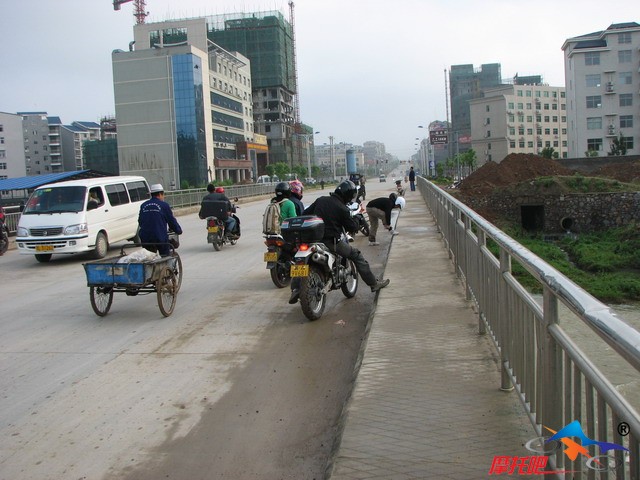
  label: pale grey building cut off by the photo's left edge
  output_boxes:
[0,112,26,180]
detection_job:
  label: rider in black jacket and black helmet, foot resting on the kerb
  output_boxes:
[289,180,389,304]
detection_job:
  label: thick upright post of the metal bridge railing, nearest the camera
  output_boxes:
[538,287,563,430]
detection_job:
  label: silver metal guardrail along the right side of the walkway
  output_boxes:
[417,177,640,480]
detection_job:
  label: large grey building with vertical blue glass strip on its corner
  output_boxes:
[112,29,256,189]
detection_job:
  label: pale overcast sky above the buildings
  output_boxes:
[0,0,640,159]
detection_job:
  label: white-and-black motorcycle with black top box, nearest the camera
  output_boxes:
[282,215,358,321]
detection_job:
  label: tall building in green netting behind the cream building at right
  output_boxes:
[449,63,502,151]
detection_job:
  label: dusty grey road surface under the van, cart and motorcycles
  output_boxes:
[0,179,394,480]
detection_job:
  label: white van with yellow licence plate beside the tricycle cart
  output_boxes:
[16,176,150,262]
